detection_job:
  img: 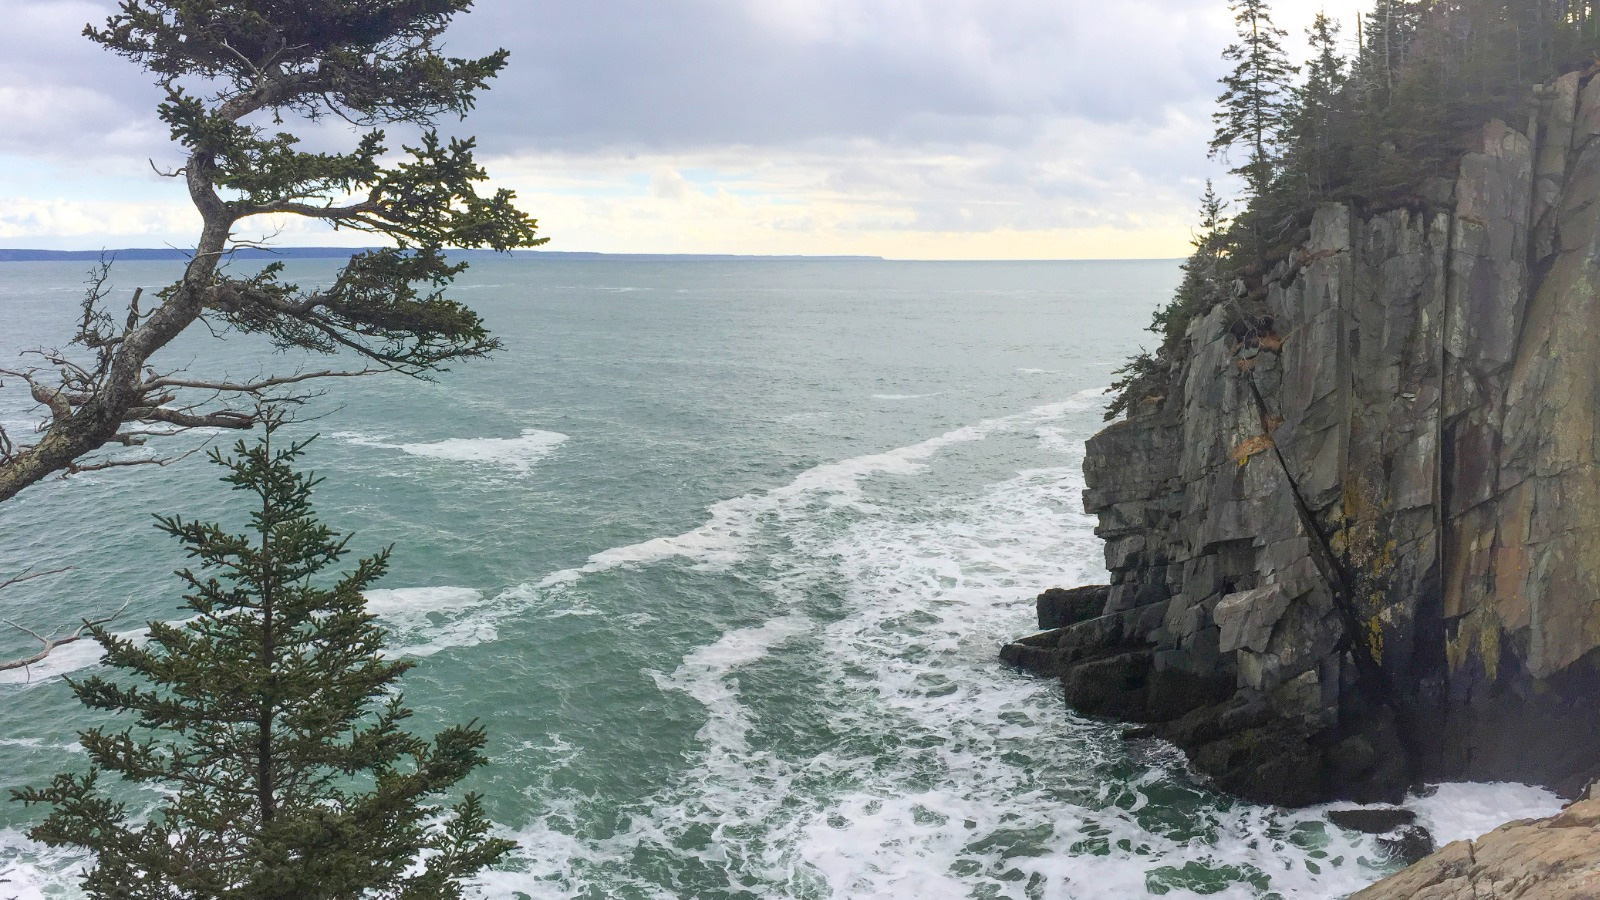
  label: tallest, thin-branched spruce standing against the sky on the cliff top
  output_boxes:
[1211,0,1298,197]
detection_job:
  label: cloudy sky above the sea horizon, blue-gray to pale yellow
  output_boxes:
[0,0,1357,259]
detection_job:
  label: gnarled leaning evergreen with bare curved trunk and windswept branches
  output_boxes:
[0,0,546,501]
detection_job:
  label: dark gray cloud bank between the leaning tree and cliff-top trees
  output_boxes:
[456,0,1224,151]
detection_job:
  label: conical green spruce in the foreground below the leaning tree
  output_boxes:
[16,424,512,900]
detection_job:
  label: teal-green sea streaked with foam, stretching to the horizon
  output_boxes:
[0,259,1549,898]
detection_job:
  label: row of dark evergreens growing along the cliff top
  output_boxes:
[1106,0,1600,420]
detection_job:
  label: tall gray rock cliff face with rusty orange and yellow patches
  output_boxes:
[1005,72,1600,806]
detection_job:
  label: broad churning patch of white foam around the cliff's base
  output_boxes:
[485,426,1550,900]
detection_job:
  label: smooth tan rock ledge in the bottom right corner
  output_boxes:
[1350,801,1600,900]
